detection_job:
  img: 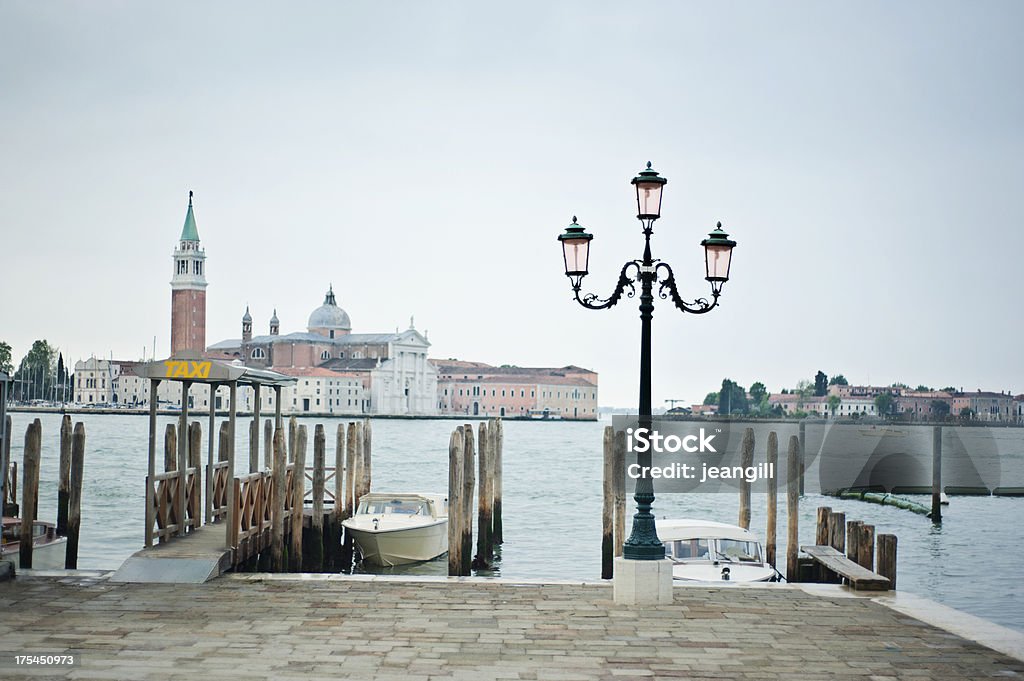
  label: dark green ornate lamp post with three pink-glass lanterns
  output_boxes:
[558,163,736,560]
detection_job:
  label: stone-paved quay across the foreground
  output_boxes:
[0,574,1024,681]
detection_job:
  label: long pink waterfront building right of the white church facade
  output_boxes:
[432,359,597,421]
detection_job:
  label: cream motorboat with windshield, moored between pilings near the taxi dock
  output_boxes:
[341,492,447,567]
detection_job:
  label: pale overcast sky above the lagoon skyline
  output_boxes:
[0,0,1024,407]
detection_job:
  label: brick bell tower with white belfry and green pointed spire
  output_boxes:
[171,191,206,355]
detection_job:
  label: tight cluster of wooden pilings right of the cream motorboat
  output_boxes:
[449,419,504,577]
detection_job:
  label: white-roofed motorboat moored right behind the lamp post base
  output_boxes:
[657,519,777,582]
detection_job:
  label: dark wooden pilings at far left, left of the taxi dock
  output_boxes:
[2,415,85,569]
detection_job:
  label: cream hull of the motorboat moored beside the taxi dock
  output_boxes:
[342,518,447,567]
